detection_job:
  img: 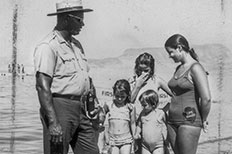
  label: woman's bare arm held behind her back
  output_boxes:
[191,64,211,122]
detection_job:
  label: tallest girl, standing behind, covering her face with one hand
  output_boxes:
[129,52,173,118]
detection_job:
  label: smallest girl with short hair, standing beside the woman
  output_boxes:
[134,90,167,154]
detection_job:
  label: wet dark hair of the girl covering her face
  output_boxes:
[134,52,155,76]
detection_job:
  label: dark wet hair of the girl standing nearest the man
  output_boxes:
[113,79,131,103]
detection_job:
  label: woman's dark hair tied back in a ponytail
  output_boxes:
[164,34,199,62]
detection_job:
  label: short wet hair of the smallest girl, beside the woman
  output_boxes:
[139,90,159,108]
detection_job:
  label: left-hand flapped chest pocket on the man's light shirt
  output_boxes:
[57,53,77,75]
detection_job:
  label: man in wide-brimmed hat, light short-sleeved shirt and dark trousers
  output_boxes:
[34,0,99,154]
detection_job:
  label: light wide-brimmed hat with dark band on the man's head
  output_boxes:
[47,0,93,16]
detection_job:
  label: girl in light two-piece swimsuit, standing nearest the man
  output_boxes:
[100,79,135,154]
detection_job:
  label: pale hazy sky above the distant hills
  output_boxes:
[0,0,232,65]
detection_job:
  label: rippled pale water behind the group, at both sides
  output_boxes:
[0,76,232,154]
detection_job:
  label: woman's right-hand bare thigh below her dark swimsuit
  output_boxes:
[177,125,201,154]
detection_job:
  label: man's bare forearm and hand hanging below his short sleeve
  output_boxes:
[36,72,62,142]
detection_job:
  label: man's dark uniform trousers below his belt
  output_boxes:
[40,97,99,154]
